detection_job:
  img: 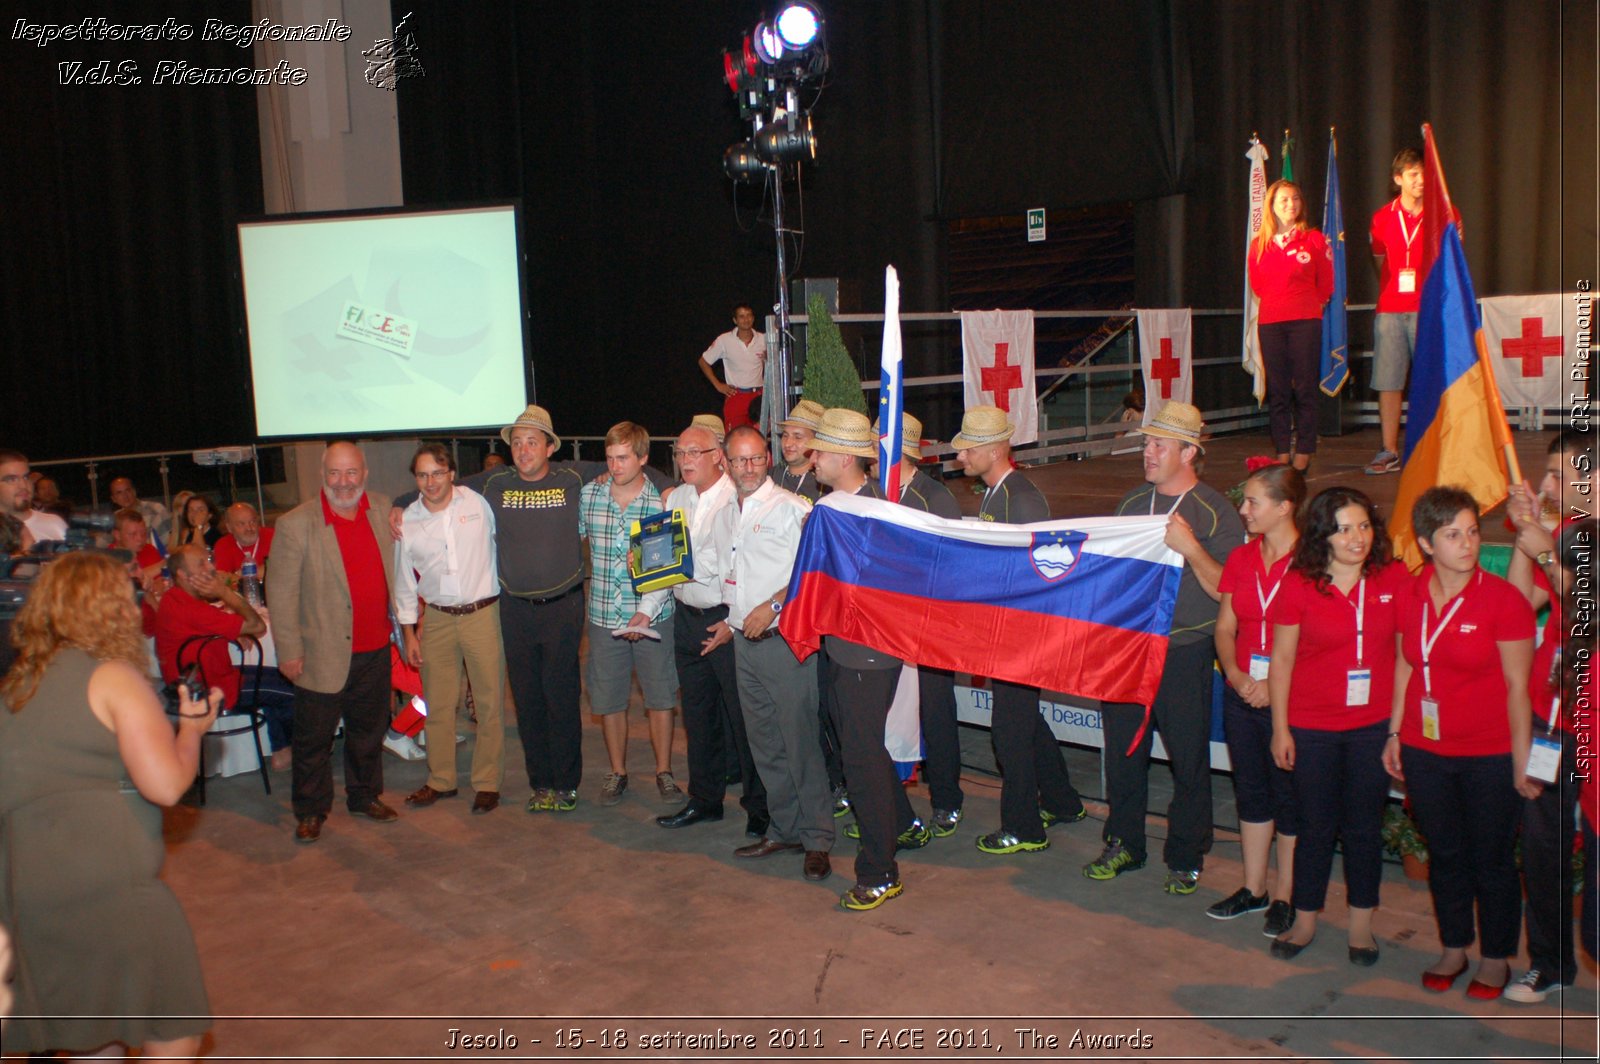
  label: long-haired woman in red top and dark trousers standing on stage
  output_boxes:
[1250,181,1333,469]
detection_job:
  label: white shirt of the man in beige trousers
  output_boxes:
[395,485,499,624]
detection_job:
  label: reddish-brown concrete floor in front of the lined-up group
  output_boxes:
[152,428,1597,1061]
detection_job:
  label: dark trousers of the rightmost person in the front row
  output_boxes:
[1522,728,1594,982]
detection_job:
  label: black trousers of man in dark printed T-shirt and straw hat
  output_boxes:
[501,592,584,790]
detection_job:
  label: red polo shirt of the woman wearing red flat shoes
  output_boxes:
[1400,566,1549,757]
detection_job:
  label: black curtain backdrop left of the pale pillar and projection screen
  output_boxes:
[0,0,262,459]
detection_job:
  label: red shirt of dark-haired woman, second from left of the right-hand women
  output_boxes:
[1267,562,1411,731]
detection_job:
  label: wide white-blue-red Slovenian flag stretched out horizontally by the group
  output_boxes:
[779,496,1182,706]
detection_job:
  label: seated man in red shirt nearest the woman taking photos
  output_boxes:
[155,544,293,771]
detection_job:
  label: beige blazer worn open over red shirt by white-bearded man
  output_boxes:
[267,491,395,694]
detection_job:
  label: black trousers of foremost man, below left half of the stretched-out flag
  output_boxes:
[822,659,915,886]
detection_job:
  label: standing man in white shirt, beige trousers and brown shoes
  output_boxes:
[394,443,506,813]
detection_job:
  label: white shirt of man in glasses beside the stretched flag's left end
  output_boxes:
[714,477,811,630]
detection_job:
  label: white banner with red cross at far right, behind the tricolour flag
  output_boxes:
[1480,293,1578,410]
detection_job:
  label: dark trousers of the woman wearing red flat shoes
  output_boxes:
[1400,746,1523,960]
